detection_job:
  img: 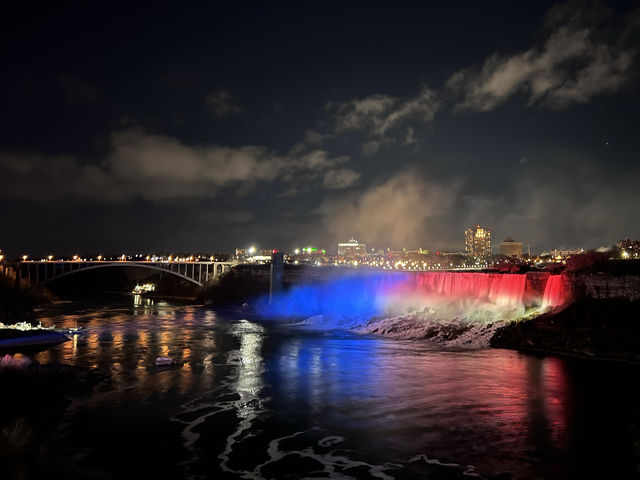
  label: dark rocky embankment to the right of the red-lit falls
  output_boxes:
[490,261,640,362]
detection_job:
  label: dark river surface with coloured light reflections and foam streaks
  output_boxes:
[28,296,640,479]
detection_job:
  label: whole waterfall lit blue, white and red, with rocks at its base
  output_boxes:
[256,272,571,348]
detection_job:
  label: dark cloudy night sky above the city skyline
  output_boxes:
[0,1,640,255]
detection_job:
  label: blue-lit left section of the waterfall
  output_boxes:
[256,272,408,317]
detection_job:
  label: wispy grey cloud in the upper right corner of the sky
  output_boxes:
[447,2,637,111]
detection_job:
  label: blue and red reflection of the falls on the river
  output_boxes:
[267,335,567,471]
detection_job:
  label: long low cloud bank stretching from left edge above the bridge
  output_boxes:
[0,129,359,202]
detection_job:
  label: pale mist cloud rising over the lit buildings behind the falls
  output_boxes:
[314,151,640,252]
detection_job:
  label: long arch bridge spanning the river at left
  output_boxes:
[16,260,238,287]
